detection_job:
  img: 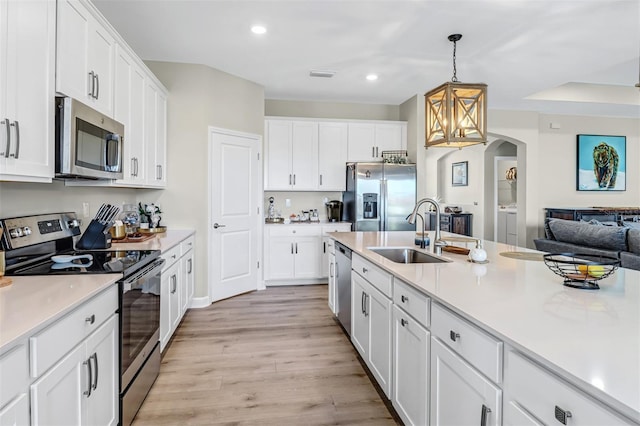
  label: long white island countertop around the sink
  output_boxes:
[330,232,640,421]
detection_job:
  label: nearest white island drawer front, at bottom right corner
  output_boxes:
[504,350,632,426]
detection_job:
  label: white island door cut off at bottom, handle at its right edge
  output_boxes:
[430,337,502,426]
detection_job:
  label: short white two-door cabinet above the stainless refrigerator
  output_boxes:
[348,122,407,162]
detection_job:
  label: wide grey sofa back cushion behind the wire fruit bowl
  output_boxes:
[549,219,628,251]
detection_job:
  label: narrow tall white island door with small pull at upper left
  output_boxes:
[392,305,430,426]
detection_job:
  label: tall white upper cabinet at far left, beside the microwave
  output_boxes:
[0,1,56,182]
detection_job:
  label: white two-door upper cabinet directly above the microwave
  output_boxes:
[56,0,116,117]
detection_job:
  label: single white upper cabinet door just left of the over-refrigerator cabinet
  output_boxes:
[318,122,349,191]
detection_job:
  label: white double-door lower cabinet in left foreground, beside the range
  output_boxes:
[31,315,119,425]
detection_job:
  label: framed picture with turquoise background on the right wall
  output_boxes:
[576,135,627,191]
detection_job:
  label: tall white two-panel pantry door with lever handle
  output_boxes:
[209,128,262,301]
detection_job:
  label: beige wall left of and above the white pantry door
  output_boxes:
[141,61,264,297]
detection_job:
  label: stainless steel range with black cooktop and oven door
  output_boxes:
[0,212,165,425]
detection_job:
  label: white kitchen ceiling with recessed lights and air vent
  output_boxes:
[93,0,640,117]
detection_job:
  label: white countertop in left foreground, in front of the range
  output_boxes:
[0,274,122,353]
